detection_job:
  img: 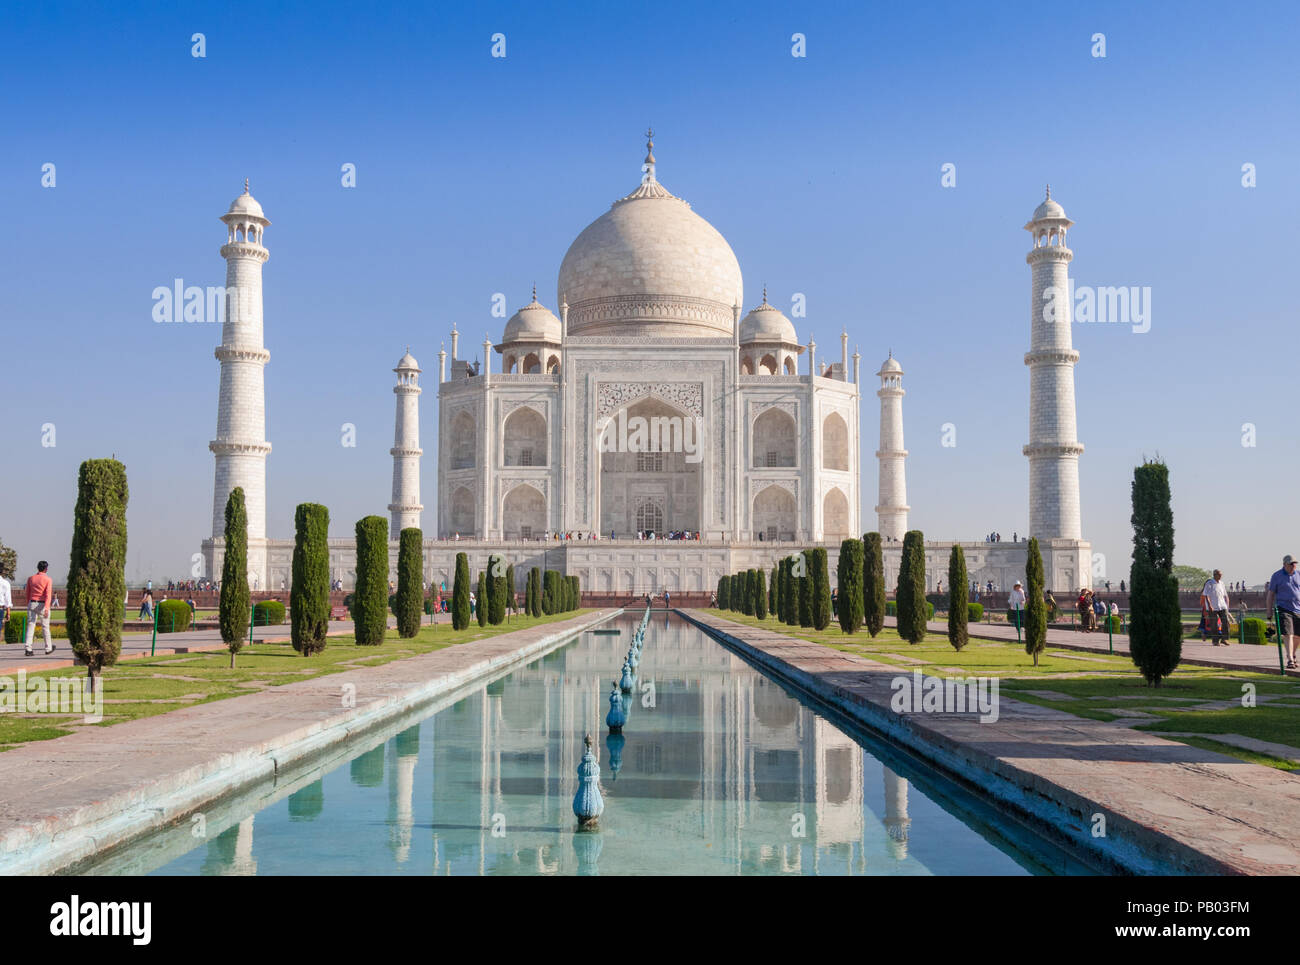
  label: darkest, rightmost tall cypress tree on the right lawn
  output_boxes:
[1128,462,1183,687]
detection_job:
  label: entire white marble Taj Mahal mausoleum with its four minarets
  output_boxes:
[203,135,1092,596]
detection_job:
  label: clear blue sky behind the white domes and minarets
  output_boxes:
[0,3,1300,583]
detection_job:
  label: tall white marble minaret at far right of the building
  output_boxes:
[1024,185,1083,540]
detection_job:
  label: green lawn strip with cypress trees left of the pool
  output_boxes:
[0,610,592,750]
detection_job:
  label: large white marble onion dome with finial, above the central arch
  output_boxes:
[558,142,744,338]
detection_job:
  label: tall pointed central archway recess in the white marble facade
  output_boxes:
[598,398,705,536]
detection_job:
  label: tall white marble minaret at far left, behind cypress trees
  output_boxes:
[208,179,270,589]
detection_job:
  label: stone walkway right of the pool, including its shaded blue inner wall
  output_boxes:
[681,610,1300,875]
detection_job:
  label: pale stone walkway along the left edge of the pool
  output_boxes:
[0,610,619,874]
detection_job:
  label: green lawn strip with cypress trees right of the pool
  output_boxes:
[719,613,1300,771]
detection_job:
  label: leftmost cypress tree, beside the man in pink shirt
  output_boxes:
[65,459,129,692]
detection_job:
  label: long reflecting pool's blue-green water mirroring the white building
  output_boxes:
[82,613,1088,875]
